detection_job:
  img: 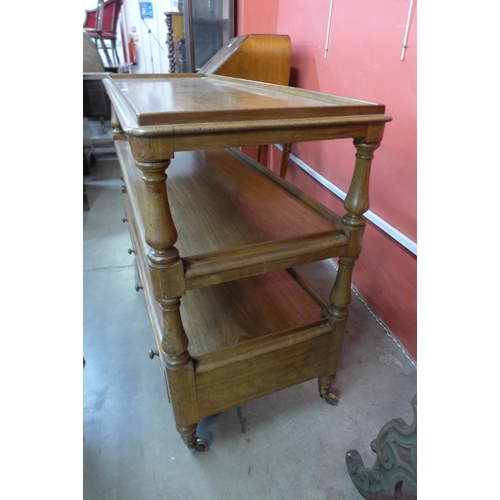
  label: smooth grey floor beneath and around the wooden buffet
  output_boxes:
[83,122,417,500]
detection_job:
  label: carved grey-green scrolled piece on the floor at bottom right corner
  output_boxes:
[346,394,417,499]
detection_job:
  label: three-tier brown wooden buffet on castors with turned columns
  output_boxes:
[104,73,390,451]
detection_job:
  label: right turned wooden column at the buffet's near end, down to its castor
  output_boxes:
[318,140,380,404]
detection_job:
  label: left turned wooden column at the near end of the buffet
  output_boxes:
[136,160,199,446]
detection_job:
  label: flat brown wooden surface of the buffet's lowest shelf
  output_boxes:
[181,271,325,360]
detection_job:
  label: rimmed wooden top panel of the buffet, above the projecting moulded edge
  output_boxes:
[104,73,385,126]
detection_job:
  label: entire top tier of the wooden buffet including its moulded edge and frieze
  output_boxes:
[104,73,391,156]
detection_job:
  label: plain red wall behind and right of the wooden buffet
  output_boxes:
[236,0,417,361]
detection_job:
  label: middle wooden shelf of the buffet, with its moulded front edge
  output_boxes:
[116,141,347,290]
